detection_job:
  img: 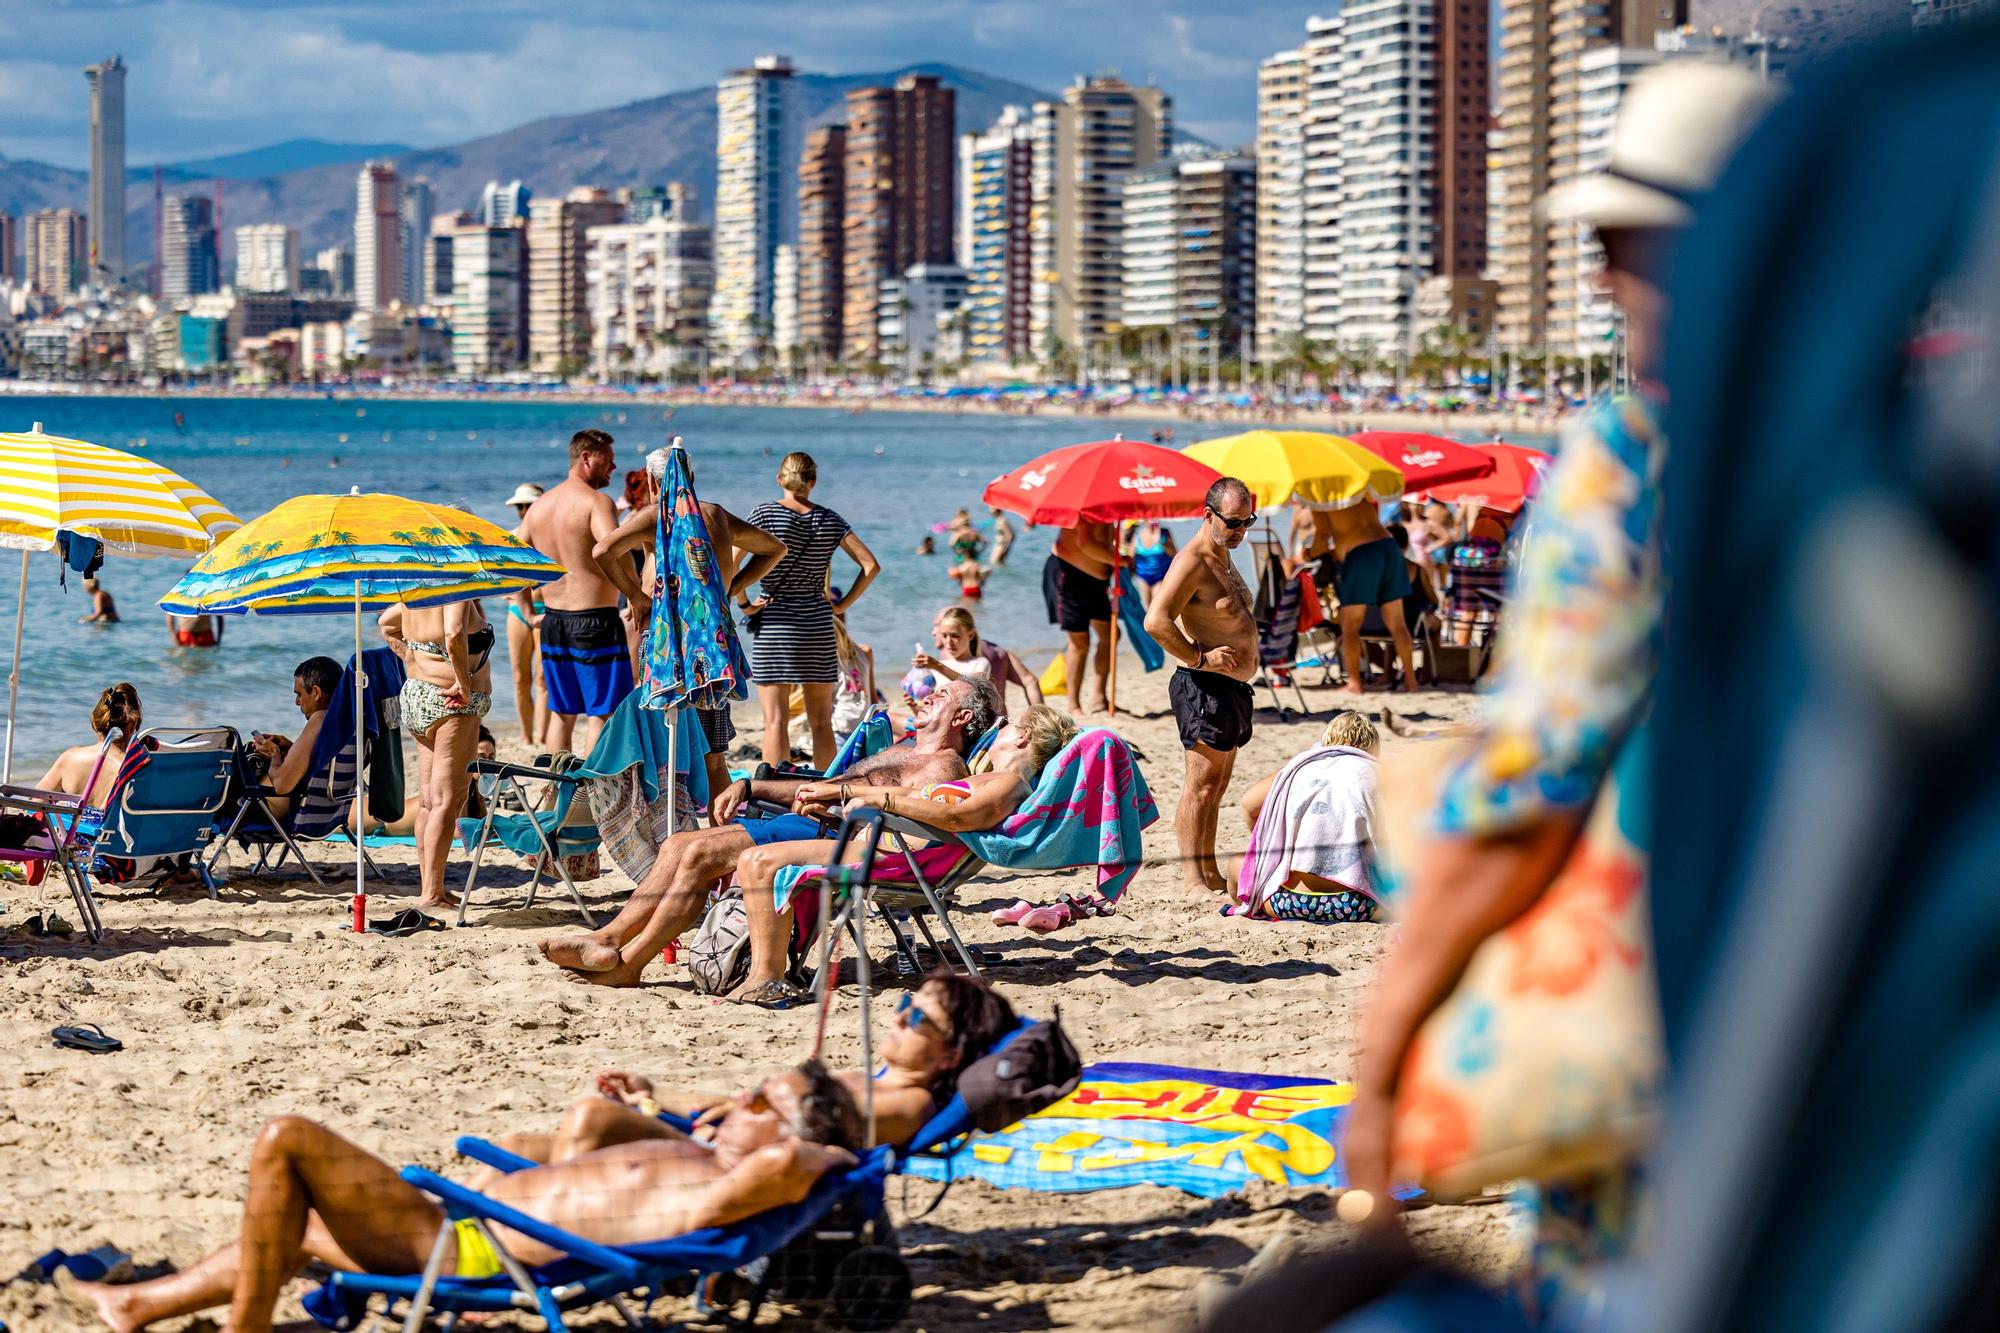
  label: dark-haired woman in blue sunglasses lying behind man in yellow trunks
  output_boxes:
[484,971,1016,1163]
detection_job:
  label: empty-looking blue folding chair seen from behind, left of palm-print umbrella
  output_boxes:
[92,727,238,899]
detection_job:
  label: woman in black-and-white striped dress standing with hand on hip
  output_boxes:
[744,454,882,773]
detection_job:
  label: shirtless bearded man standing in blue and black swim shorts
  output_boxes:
[514,430,646,755]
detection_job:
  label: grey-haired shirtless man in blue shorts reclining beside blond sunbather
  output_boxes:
[538,677,1000,987]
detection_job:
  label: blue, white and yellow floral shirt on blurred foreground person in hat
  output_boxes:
[1436,396,1666,837]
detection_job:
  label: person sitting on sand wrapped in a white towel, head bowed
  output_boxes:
[1224,713,1378,923]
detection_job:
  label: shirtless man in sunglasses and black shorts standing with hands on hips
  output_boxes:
[1146,476,1256,893]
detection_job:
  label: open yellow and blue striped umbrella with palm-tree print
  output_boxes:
[160,488,564,931]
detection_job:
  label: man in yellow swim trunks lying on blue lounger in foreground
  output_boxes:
[66,1061,862,1333]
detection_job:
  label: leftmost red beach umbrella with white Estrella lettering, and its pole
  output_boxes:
[982,434,1222,713]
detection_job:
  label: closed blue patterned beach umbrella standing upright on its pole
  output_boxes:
[644,434,750,837]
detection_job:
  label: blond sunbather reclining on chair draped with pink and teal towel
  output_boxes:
[732,705,1076,1009]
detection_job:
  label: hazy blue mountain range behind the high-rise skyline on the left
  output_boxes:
[0,64,1052,274]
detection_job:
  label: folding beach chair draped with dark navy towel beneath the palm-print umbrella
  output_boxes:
[204,648,404,889]
